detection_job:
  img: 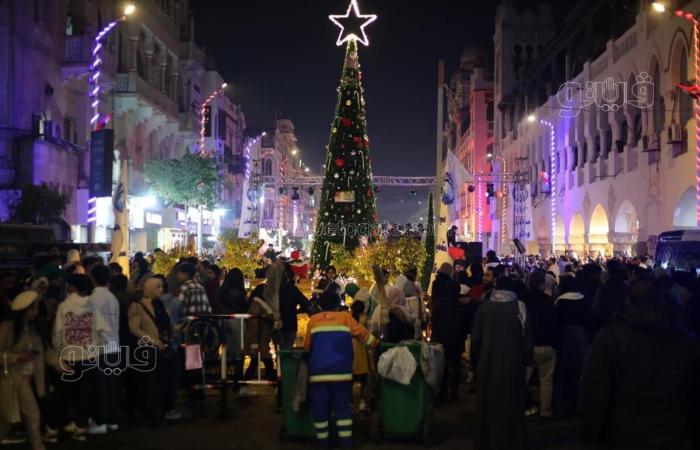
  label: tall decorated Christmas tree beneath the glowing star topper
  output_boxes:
[311,39,377,267]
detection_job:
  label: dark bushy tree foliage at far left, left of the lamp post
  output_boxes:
[13,183,70,224]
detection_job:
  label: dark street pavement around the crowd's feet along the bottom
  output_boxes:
[46,388,584,450]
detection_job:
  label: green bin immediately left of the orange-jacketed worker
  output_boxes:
[279,349,316,440]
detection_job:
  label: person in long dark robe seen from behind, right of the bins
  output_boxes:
[471,277,532,450]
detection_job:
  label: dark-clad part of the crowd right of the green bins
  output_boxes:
[432,252,700,450]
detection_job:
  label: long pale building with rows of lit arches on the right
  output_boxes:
[489,1,700,256]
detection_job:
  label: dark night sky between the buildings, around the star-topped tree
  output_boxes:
[190,0,496,223]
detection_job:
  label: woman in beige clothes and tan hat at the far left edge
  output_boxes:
[0,291,55,450]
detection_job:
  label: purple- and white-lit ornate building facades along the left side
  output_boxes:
[0,0,245,251]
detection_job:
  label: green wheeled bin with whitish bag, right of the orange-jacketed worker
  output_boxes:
[372,342,436,446]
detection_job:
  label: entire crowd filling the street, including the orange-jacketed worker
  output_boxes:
[0,246,700,450]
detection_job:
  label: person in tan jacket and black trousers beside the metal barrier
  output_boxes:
[129,278,182,427]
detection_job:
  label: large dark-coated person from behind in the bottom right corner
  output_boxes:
[581,276,700,450]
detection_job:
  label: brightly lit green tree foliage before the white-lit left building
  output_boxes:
[144,153,218,209]
